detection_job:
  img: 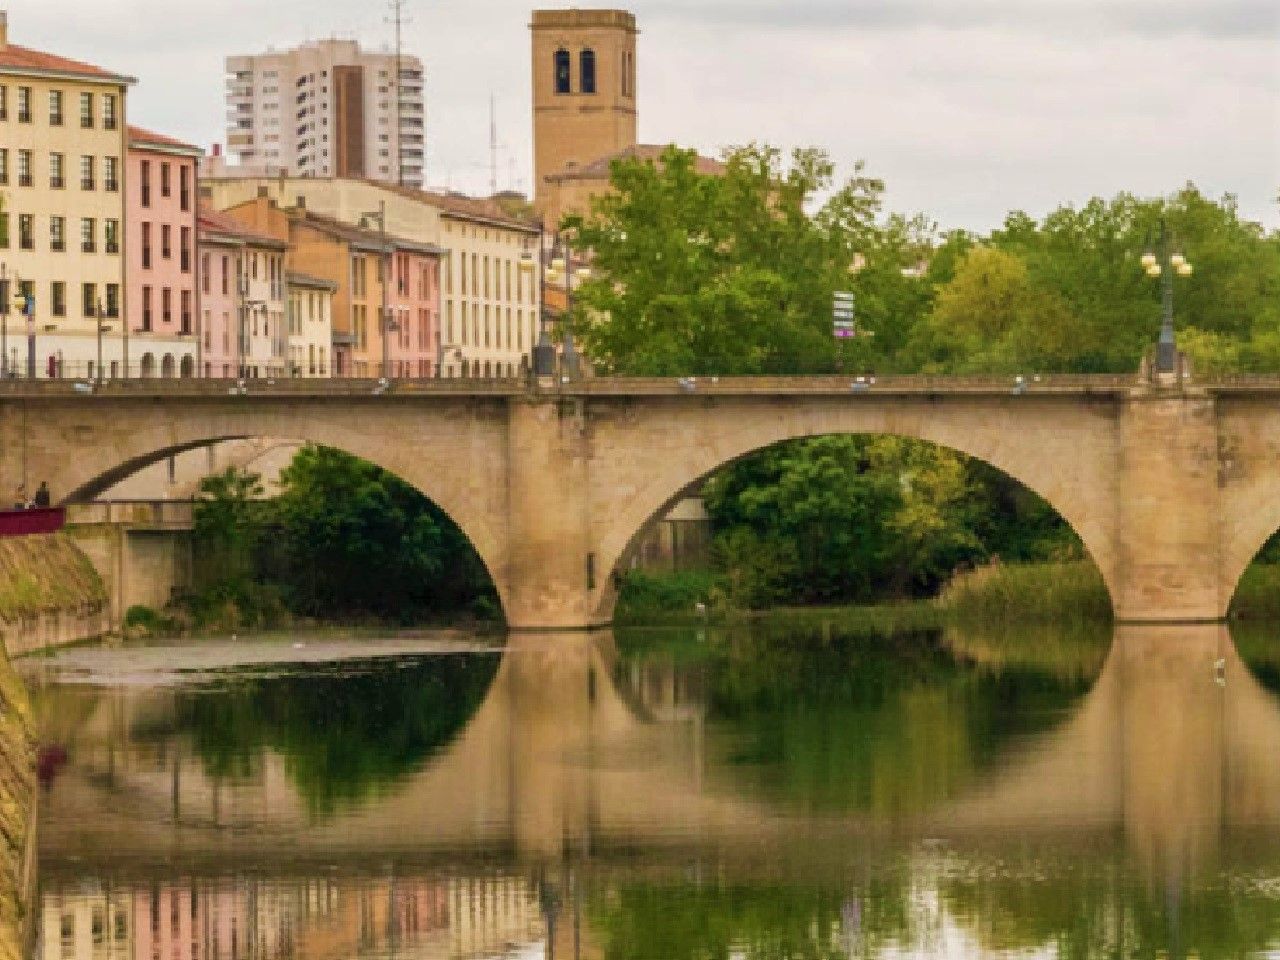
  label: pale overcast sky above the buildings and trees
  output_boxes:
[12,0,1280,230]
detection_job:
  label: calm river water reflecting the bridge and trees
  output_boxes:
[10,616,1280,960]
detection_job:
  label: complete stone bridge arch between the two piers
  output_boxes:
[594,398,1117,622]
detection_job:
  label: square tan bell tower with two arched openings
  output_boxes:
[529,10,639,206]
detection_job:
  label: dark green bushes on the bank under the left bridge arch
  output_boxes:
[182,445,500,631]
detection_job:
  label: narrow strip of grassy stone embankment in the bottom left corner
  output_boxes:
[0,652,36,960]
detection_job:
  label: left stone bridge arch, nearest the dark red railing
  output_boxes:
[47,398,509,619]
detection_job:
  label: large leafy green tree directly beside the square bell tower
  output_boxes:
[564,145,883,376]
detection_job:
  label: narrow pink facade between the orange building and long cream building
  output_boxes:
[388,243,443,379]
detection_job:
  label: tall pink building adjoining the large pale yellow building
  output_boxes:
[124,127,201,376]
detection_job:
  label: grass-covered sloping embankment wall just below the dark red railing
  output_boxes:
[0,534,111,657]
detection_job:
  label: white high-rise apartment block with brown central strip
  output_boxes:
[227,40,426,187]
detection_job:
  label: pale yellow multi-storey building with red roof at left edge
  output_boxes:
[0,13,133,376]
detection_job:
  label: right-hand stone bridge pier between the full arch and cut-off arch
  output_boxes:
[1112,390,1231,623]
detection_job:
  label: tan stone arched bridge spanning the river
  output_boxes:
[0,376,1280,630]
